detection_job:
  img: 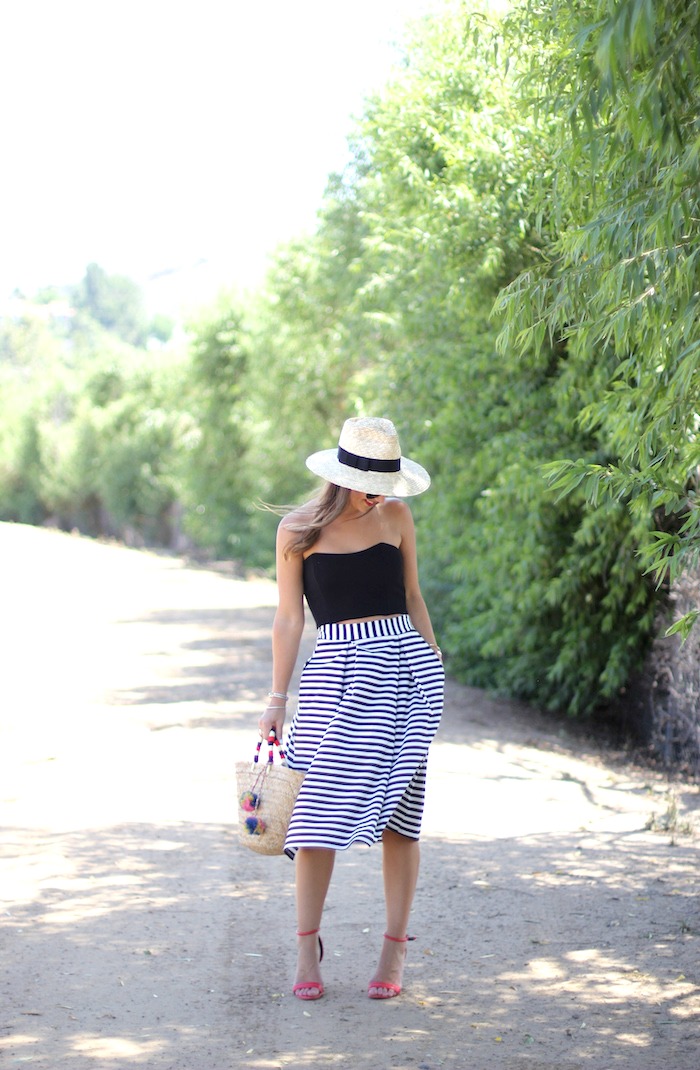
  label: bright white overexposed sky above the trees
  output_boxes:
[0,0,440,312]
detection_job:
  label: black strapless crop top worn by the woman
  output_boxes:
[304,542,407,627]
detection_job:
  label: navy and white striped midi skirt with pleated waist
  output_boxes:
[285,615,444,858]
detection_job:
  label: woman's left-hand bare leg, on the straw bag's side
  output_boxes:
[294,847,335,996]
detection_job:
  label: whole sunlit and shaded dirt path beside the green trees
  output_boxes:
[0,524,700,1070]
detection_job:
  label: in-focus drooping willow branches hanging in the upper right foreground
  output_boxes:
[499,0,700,631]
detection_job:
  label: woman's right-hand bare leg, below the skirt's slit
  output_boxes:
[369,828,421,998]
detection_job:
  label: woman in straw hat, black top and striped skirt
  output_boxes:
[259,417,444,999]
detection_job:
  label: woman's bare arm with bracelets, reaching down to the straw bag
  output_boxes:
[259,520,304,740]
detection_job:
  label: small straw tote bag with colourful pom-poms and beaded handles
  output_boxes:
[235,733,304,855]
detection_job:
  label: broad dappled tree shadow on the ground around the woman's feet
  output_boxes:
[2,824,700,1070]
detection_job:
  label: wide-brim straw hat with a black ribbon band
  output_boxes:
[306,416,430,498]
